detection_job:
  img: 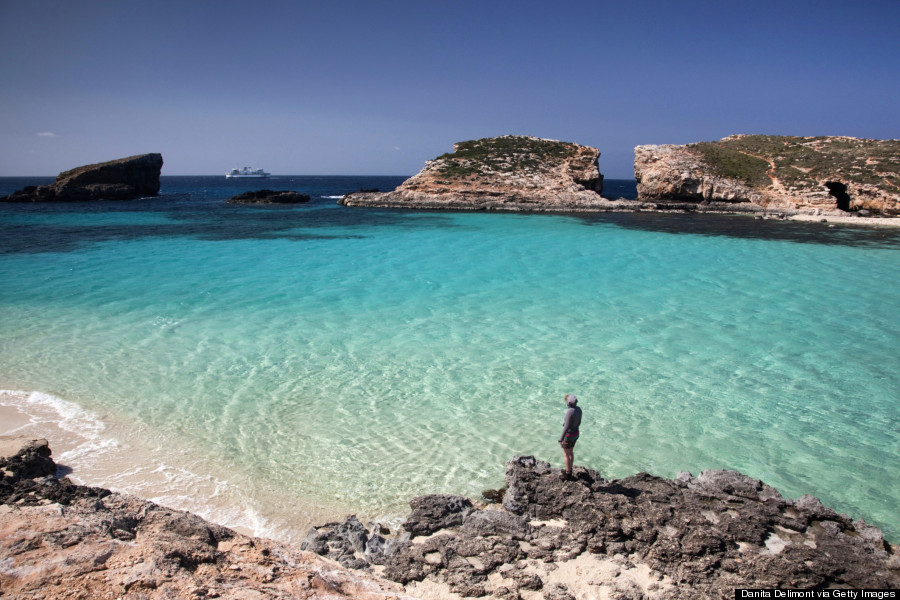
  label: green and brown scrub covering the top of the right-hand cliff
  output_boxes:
[688,135,900,194]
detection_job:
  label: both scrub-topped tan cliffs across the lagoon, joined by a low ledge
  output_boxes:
[339,135,900,225]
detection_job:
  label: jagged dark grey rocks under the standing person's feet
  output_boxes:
[304,456,900,599]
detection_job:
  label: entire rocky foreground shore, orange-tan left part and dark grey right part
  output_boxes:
[0,438,900,600]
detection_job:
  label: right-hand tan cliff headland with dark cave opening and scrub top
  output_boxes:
[634,135,900,216]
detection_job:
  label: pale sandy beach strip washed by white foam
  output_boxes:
[0,390,343,543]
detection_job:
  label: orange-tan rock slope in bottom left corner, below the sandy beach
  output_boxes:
[0,439,408,600]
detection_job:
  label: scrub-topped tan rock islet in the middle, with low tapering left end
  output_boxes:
[339,135,605,211]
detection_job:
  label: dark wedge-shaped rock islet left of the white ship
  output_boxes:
[0,154,163,202]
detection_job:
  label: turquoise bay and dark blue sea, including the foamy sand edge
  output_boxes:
[0,176,900,543]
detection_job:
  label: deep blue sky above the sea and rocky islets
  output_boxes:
[0,0,900,178]
